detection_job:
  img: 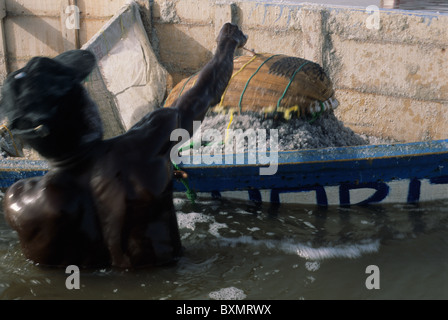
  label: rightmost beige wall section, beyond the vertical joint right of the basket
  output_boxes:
[325,5,448,141]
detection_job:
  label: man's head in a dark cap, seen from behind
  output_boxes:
[0,50,102,158]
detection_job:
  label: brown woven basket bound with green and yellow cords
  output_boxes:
[165,53,338,119]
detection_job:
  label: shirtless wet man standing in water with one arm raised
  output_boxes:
[2,24,247,268]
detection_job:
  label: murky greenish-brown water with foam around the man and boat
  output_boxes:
[0,195,448,300]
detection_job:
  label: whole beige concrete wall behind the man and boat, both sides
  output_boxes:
[0,0,448,141]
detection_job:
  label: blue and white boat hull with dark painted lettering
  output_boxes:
[0,139,448,206]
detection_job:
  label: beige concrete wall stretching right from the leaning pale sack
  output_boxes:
[152,0,448,141]
